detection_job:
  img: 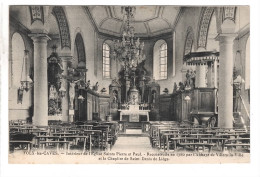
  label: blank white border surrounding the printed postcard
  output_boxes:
[0,0,260,177]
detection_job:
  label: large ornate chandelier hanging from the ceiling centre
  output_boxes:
[112,6,145,70]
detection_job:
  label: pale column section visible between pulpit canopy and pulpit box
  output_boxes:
[195,64,207,88]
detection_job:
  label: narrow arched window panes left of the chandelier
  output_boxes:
[103,43,110,79]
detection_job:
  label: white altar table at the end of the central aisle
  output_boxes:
[118,105,150,122]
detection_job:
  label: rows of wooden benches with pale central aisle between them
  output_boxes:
[9,121,250,156]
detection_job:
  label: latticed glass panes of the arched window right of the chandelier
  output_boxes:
[159,43,167,79]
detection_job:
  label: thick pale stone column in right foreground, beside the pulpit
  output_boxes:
[218,34,235,128]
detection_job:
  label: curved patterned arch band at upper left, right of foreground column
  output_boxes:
[52,6,71,49]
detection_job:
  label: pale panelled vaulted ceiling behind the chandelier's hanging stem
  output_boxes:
[85,6,181,37]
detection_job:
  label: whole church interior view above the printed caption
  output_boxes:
[8,6,250,153]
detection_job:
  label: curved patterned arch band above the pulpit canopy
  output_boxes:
[198,7,214,49]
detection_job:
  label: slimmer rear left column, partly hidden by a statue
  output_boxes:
[60,56,72,122]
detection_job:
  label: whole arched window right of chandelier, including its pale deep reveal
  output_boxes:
[153,40,167,80]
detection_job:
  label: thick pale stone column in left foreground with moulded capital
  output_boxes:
[29,34,50,126]
